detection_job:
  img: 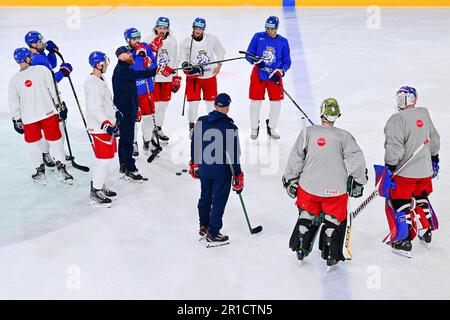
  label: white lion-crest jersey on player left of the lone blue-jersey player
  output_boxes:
[180,33,226,79]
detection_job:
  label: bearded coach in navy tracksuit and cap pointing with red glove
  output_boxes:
[112,46,173,182]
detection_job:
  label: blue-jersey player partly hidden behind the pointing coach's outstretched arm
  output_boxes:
[123,28,162,156]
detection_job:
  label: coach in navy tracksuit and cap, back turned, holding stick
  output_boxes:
[189,93,244,246]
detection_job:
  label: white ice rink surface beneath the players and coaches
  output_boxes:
[0,8,450,299]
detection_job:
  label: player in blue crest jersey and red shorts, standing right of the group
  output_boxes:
[247,16,291,140]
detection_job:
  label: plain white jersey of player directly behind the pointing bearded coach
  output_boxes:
[84,74,117,133]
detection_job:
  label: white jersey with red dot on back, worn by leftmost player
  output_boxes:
[8,66,58,124]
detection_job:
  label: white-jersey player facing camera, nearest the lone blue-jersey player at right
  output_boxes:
[180,18,226,136]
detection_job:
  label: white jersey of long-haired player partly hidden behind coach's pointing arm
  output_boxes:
[145,33,178,82]
